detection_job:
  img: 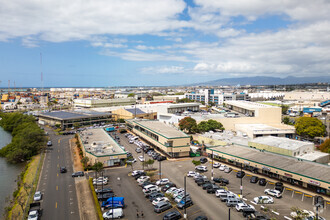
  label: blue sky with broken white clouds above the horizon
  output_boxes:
[0,0,330,88]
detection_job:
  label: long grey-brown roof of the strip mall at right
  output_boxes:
[210,145,330,183]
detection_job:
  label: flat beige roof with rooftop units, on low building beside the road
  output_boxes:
[80,128,126,157]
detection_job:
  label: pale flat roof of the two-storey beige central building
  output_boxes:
[127,119,189,138]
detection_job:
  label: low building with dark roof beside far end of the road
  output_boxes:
[39,111,113,129]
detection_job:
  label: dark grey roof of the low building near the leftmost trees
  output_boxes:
[39,111,111,120]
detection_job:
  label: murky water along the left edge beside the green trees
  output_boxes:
[0,127,24,219]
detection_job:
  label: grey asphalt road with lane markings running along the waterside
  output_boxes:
[37,128,79,220]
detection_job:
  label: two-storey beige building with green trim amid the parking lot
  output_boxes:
[126,119,190,157]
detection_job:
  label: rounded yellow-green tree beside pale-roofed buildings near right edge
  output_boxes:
[294,117,325,138]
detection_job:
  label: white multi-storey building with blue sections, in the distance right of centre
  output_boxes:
[185,89,249,105]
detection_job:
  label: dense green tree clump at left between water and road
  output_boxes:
[0,113,46,163]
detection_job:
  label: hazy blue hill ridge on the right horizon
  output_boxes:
[198,76,330,86]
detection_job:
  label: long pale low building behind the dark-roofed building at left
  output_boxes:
[73,98,136,108]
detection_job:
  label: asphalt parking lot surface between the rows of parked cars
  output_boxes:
[98,130,330,219]
